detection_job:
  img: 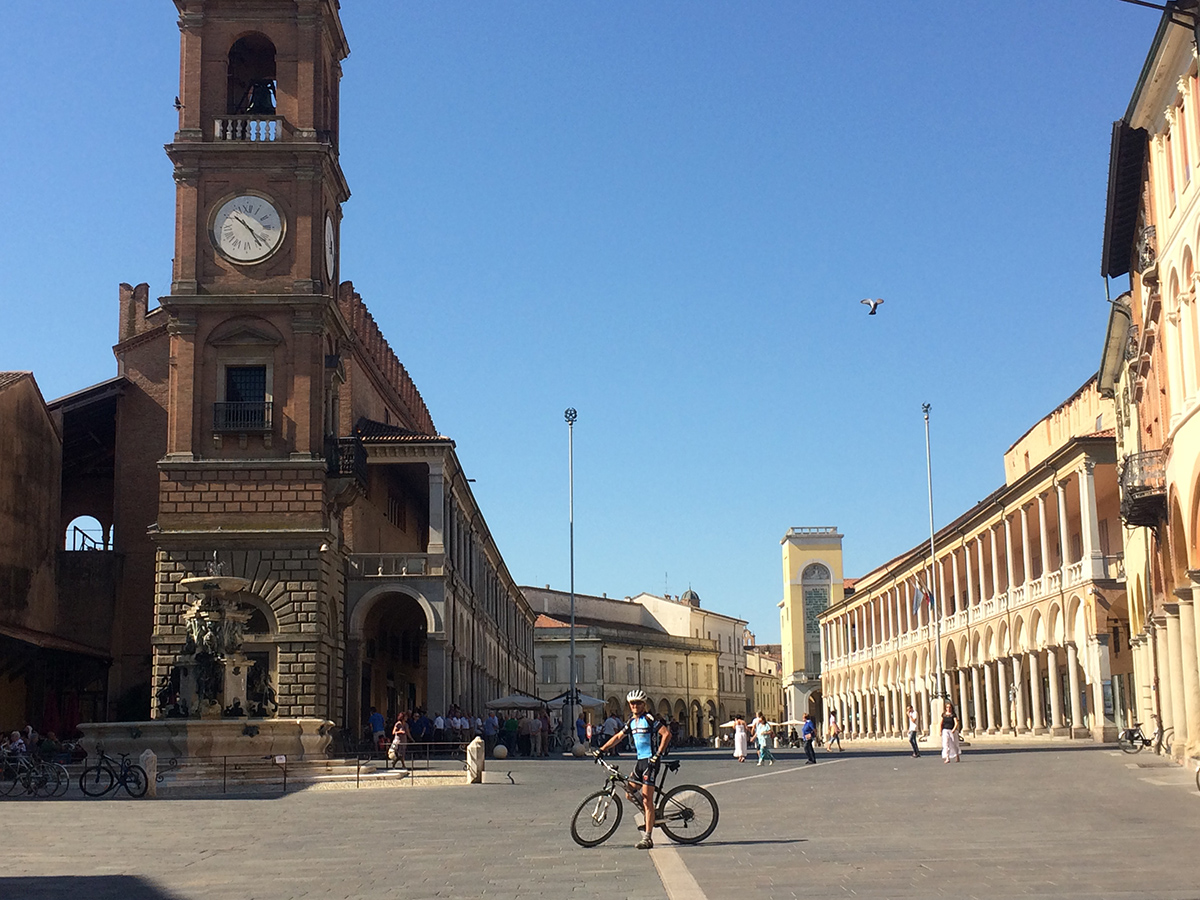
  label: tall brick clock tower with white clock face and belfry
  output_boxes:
[152,0,349,721]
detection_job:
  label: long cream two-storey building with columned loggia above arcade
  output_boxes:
[820,378,1135,740]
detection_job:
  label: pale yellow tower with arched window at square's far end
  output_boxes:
[779,527,842,721]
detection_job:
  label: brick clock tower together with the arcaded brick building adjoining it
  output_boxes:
[2,0,534,734]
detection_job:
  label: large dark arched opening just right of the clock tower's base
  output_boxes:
[360,593,429,722]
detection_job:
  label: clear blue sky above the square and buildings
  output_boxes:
[0,0,1158,641]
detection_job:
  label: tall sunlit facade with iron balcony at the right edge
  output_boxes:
[1100,10,1200,761]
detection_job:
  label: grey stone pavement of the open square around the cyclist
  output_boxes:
[0,742,1200,900]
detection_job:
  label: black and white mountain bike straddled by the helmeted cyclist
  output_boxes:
[571,755,720,847]
